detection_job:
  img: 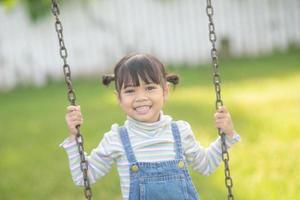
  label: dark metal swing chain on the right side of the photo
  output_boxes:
[206,0,234,200]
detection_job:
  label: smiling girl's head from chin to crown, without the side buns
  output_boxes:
[114,54,168,122]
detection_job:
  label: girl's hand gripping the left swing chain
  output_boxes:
[65,105,83,140]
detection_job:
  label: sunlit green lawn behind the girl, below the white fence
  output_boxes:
[0,51,300,200]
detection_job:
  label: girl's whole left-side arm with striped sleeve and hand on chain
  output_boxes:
[60,106,116,186]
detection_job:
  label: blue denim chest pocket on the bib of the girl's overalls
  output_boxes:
[140,174,188,200]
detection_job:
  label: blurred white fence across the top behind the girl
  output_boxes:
[0,0,300,90]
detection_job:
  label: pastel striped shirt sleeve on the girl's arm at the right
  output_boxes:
[177,121,240,176]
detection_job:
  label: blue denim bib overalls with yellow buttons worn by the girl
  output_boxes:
[119,122,199,200]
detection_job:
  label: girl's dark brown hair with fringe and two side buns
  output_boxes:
[102,53,179,93]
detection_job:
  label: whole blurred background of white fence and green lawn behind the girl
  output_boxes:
[0,0,300,200]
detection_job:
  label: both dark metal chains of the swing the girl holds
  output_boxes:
[51,0,234,200]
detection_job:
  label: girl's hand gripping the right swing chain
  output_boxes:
[214,106,235,137]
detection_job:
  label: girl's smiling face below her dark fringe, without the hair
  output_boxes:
[118,79,169,123]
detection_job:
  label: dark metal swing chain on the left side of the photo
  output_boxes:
[52,0,92,200]
